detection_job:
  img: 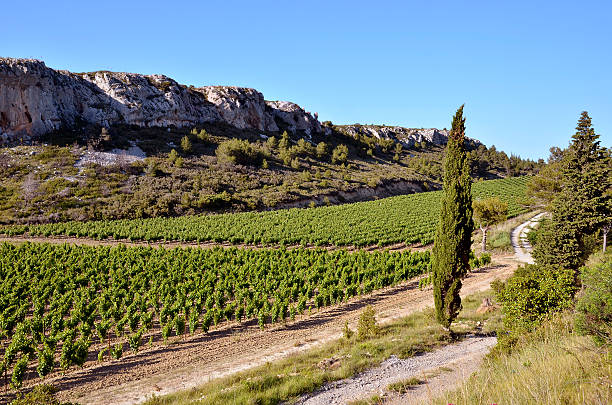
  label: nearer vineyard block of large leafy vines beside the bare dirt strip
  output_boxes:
[0,243,429,388]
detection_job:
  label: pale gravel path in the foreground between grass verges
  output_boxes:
[297,336,497,405]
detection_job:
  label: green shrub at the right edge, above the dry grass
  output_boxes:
[575,254,612,344]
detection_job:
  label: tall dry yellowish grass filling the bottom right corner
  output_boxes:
[434,313,612,405]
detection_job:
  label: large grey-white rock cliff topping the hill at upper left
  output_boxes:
[0,58,321,140]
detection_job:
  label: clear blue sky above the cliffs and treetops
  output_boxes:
[0,0,612,159]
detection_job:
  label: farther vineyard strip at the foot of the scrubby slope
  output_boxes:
[0,177,528,246]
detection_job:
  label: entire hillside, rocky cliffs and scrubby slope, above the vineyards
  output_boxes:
[0,58,539,224]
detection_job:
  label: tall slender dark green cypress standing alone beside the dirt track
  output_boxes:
[431,106,474,329]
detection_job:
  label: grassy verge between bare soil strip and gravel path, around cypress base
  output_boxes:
[146,290,501,405]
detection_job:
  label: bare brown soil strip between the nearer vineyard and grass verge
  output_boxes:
[0,252,517,404]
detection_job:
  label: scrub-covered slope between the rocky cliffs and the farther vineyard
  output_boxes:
[0,125,541,224]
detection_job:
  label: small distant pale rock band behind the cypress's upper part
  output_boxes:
[338,124,480,148]
